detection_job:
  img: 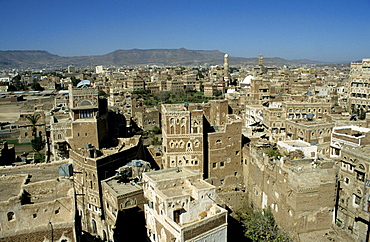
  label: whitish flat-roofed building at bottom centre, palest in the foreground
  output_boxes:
[143,167,227,242]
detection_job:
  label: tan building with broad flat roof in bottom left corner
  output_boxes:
[0,163,79,242]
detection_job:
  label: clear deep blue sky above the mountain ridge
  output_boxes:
[0,0,370,62]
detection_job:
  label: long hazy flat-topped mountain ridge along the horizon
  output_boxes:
[0,48,332,69]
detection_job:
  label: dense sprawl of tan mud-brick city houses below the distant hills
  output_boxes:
[0,55,370,241]
